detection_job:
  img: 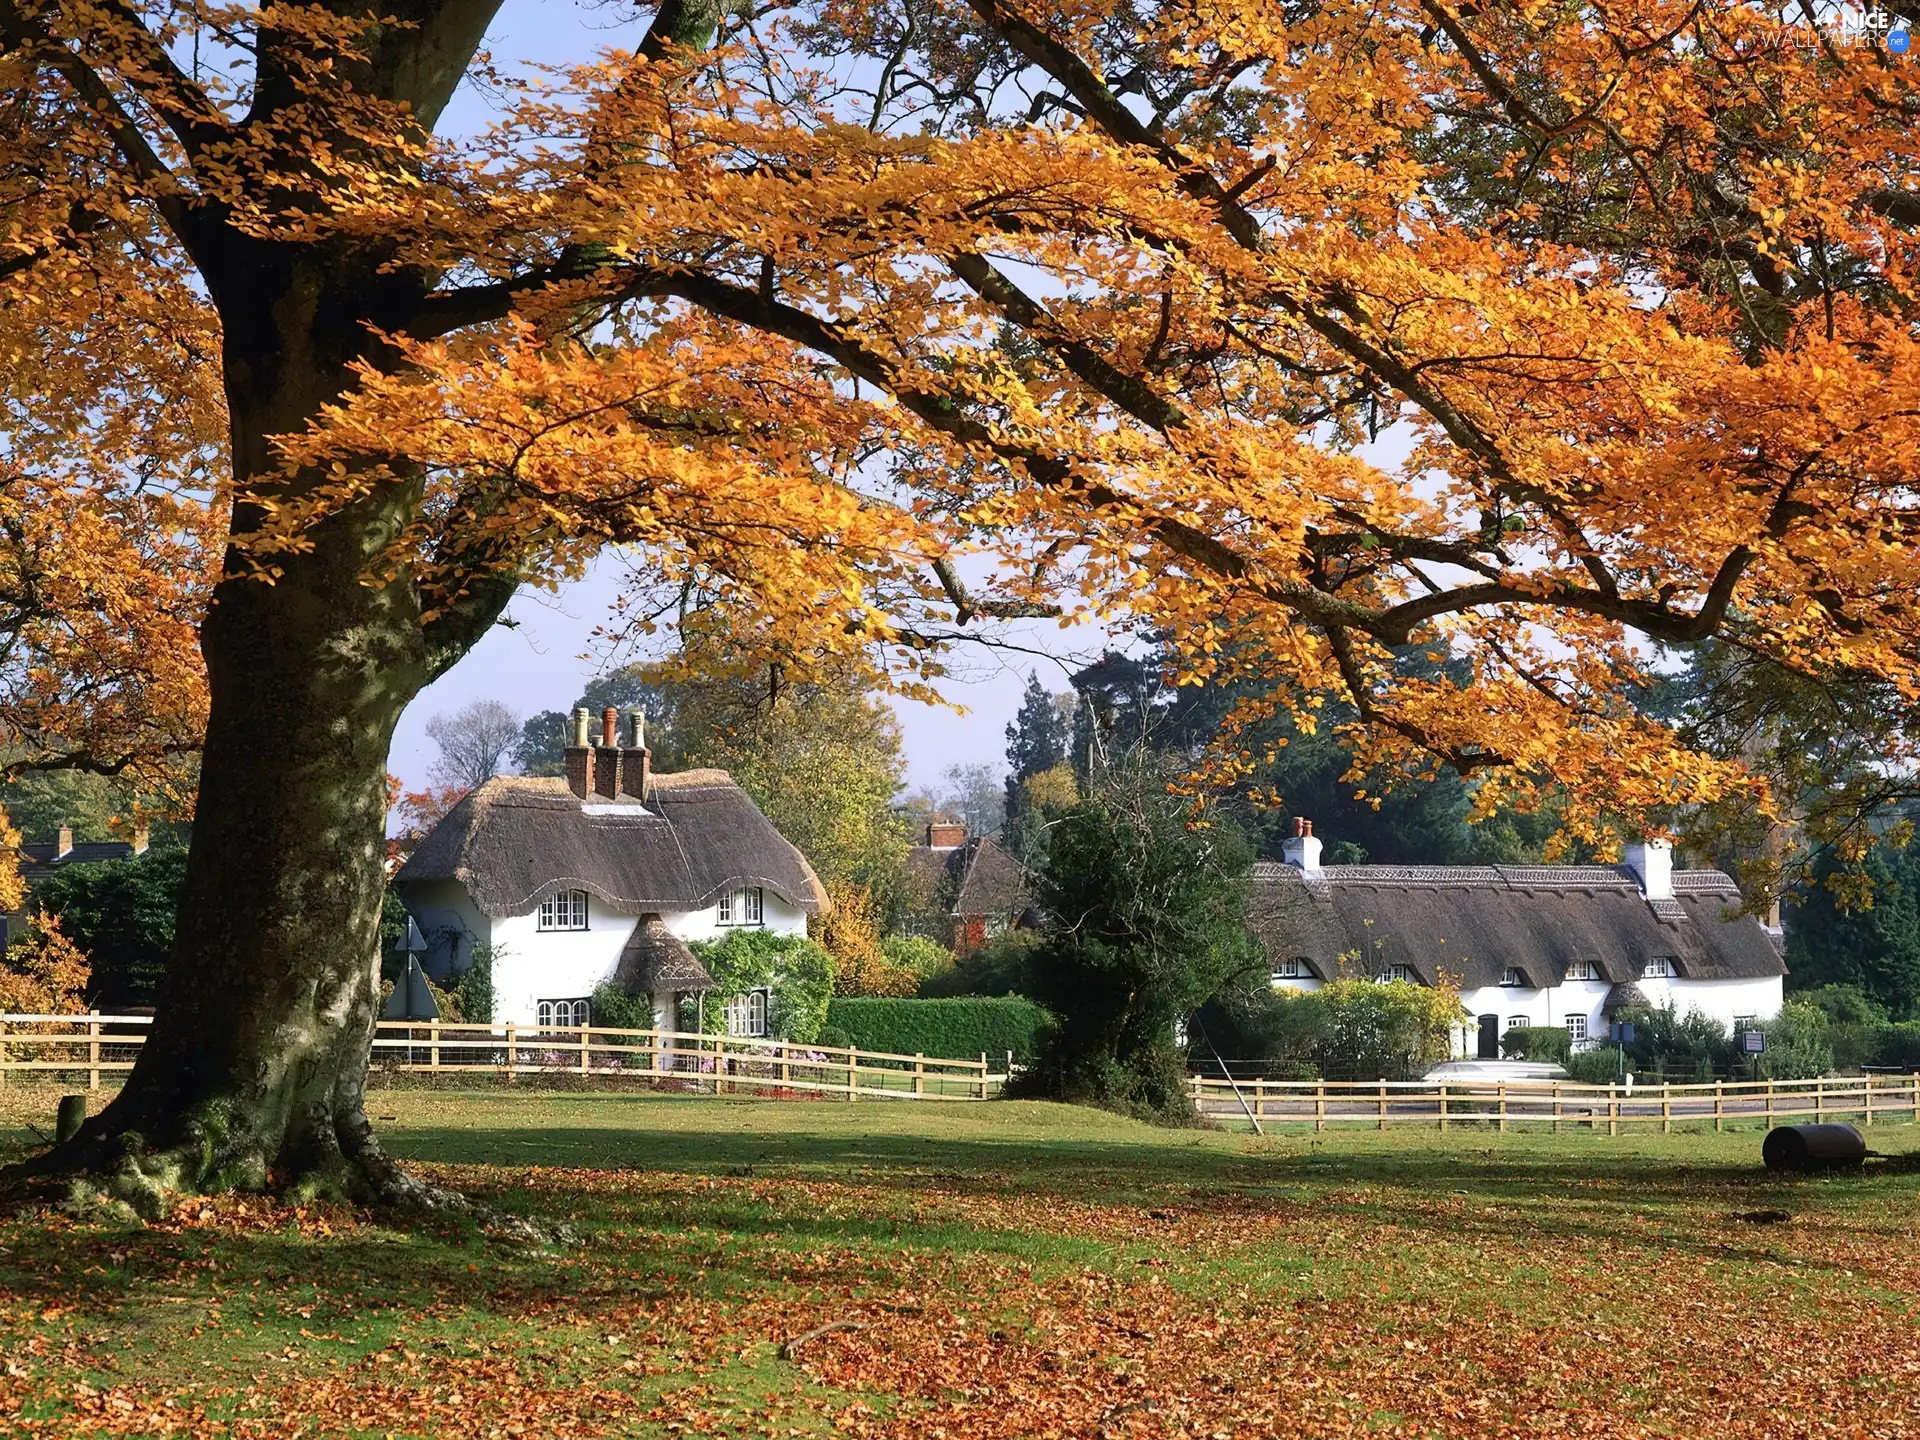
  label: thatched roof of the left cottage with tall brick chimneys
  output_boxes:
[394,770,828,916]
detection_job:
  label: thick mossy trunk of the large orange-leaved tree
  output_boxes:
[9,248,511,1213]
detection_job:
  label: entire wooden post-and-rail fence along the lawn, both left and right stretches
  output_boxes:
[11,1014,1920,1135]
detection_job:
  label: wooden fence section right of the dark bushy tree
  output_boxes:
[1190,1075,1920,1135]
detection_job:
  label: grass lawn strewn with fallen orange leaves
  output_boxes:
[0,1091,1920,1440]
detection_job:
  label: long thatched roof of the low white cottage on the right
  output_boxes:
[1248,864,1786,989]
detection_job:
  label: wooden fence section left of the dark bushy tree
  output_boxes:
[0,1014,1014,1100]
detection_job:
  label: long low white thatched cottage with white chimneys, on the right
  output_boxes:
[1250,824,1786,1060]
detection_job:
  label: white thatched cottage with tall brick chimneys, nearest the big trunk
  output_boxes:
[394,708,828,1033]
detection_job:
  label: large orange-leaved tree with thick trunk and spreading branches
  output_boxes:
[0,0,1920,1202]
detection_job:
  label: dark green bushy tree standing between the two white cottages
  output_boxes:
[1018,751,1265,1121]
